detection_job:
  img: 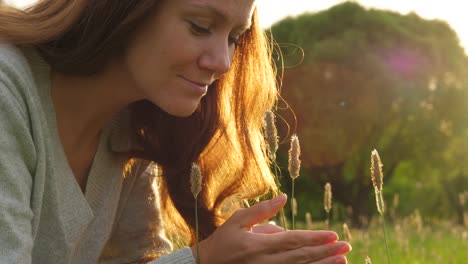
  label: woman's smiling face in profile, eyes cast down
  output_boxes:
[124,0,255,116]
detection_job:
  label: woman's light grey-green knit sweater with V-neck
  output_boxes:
[0,43,195,264]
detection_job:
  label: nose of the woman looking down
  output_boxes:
[198,38,234,78]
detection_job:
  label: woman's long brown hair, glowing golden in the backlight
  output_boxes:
[0,0,277,252]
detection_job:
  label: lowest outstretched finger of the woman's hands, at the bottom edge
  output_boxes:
[270,241,351,264]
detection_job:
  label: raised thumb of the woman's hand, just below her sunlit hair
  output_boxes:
[230,194,287,229]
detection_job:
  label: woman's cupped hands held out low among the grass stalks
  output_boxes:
[192,194,351,264]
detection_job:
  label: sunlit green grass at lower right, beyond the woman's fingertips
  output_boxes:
[298,219,468,264]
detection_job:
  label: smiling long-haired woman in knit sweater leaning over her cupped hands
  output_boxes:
[0,0,350,263]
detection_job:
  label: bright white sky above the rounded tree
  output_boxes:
[5,0,468,53]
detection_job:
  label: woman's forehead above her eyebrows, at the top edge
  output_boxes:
[181,0,256,24]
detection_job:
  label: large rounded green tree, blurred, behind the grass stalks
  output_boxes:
[271,2,468,224]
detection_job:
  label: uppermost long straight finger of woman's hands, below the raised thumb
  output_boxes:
[255,230,338,252]
